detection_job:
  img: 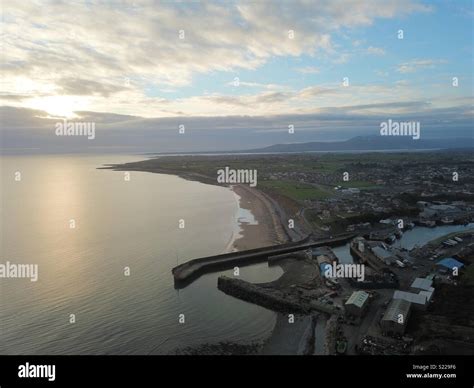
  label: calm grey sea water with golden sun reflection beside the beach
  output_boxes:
[0,155,281,354]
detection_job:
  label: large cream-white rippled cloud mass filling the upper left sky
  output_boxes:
[1,0,428,118]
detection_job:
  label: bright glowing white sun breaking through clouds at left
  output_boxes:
[29,96,87,118]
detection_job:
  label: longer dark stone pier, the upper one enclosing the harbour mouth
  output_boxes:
[172,234,355,288]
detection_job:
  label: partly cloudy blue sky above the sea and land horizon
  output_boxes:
[0,0,474,151]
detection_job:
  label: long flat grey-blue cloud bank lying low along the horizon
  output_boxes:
[0,103,474,155]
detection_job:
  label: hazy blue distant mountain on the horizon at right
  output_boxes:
[248,136,474,153]
